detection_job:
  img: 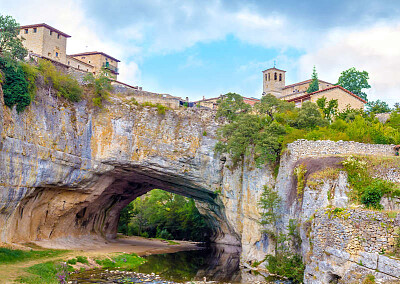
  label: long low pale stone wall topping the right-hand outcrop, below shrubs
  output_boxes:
[287,139,395,157]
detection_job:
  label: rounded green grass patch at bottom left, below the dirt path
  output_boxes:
[17,261,73,284]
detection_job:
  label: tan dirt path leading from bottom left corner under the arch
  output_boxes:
[0,237,197,283]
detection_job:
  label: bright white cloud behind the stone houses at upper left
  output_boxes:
[0,0,140,84]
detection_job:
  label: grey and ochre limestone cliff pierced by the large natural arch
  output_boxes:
[0,86,272,259]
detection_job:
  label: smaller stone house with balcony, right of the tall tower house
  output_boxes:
[68,51,120,80]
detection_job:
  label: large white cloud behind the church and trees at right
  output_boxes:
[299,22,400,104]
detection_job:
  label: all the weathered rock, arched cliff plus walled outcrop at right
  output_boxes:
[0,84,400,283]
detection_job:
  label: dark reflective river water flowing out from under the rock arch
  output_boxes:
[72,245,283,284]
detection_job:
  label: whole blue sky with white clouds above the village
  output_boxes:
[0,0,400,105]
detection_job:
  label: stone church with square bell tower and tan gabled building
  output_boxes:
[262,67,367,111]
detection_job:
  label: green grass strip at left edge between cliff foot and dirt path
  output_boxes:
[0,248,67,264]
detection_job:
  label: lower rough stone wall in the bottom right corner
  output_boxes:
[305,209,400,284]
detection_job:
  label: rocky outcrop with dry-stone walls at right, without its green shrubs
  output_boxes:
[275,140,400,284]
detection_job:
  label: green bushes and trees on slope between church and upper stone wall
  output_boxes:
[216,93,400,168]
